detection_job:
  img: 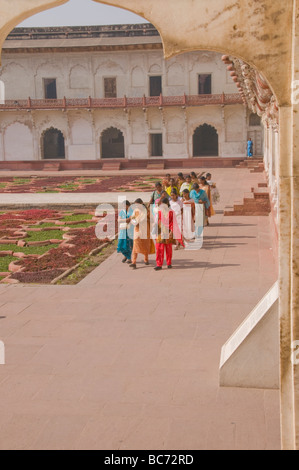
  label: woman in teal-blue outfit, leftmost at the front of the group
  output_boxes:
[117,201,134,263]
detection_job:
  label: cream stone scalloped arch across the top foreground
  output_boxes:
[0,0,294,106]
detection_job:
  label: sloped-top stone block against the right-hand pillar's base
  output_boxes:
[220,283,279,389]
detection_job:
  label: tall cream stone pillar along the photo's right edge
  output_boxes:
[279,0,299,450]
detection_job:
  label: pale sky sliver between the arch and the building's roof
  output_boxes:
[18,0,146,28]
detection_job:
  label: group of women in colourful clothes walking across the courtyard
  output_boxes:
[117,172,216,271]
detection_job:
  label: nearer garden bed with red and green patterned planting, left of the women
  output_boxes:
[0,209,116,284]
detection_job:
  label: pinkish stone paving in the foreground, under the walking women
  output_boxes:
[0,170,280,450]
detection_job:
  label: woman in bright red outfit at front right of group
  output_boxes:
[155,198,184,271]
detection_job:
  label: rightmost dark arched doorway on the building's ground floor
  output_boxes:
[193,124,219,157]
